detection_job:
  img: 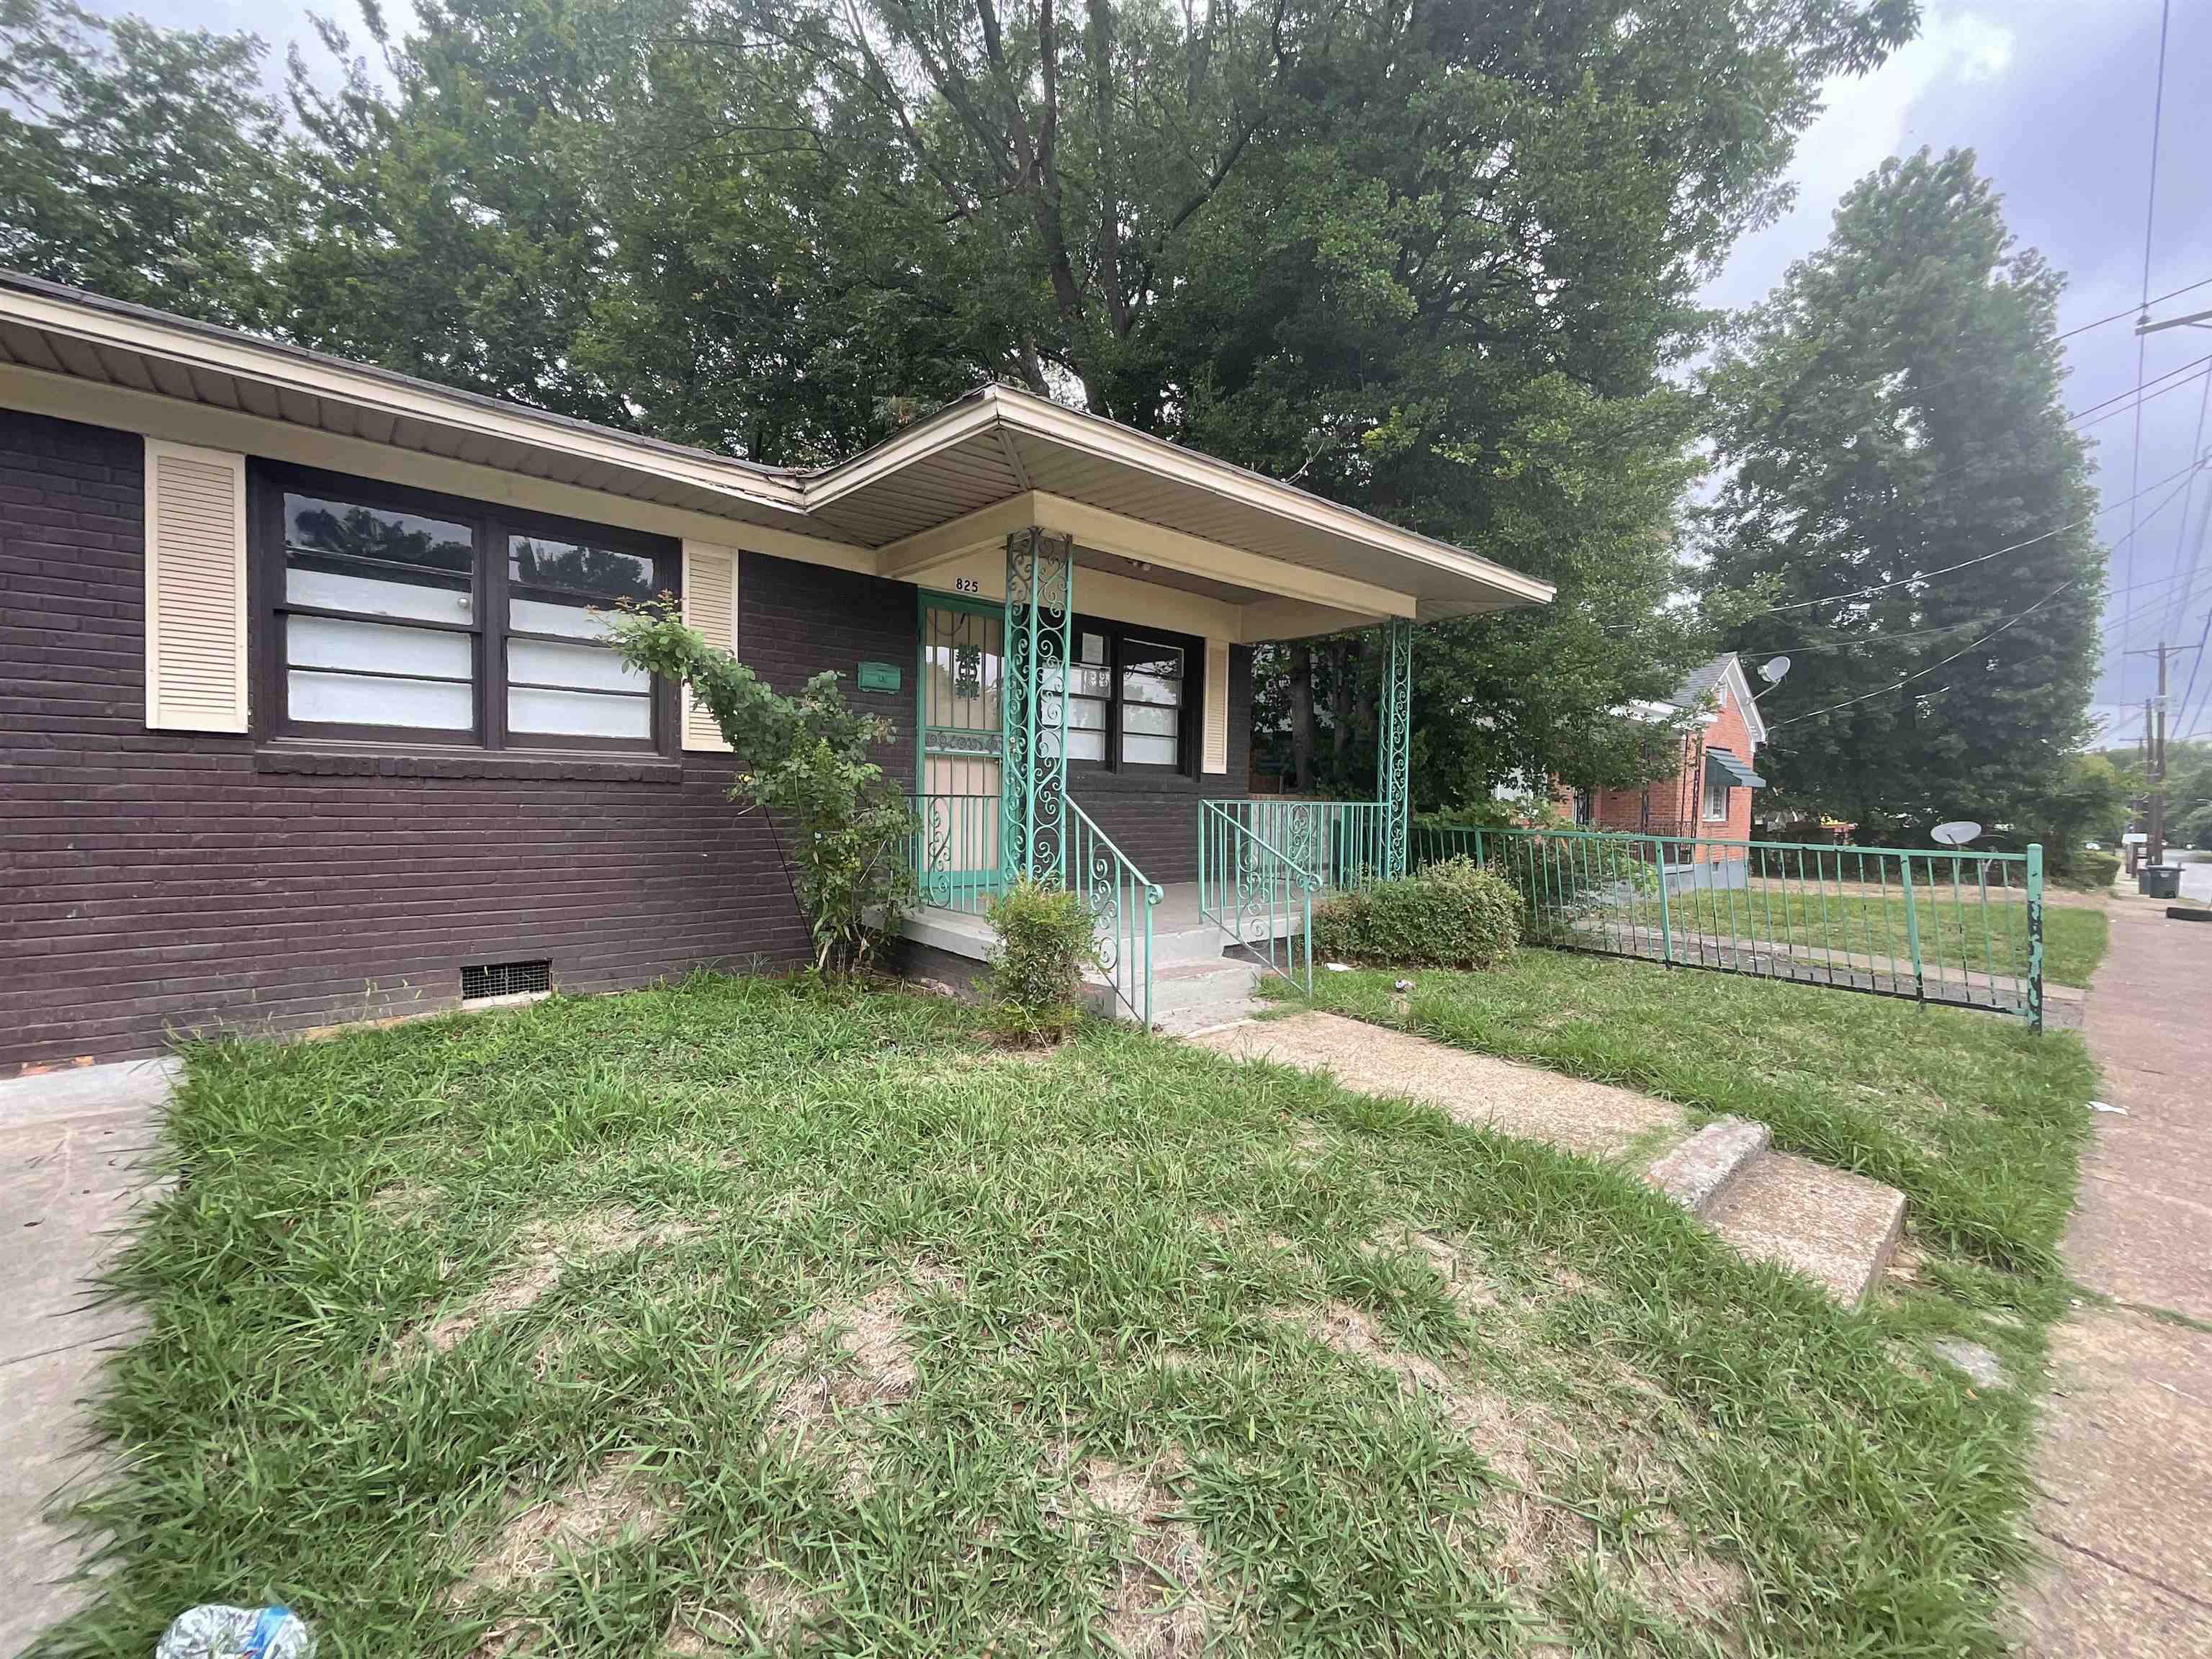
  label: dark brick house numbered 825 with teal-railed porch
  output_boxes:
[0,274,1550,1073]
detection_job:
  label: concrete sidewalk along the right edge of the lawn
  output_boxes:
[2015,894,2212,1659]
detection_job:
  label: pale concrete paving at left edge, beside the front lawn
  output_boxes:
[0,1062,171,1655]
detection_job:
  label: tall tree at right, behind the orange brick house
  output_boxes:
[1706,150,2103,830]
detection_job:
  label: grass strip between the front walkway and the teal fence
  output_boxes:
[1314,942,2103,1279]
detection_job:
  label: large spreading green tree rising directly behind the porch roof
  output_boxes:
[11,0,1915,801]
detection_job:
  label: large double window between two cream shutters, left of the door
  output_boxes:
[254,475,677,750]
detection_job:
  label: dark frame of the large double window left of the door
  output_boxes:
[246,460,683,759]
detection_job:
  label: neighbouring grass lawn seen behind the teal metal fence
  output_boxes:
[1639,881,2110,986]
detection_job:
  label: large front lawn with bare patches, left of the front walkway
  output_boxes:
[64,981,2070,1657]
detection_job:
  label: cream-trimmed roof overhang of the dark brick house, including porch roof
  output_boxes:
[0,272,1553,637]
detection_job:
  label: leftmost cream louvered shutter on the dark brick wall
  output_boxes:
[146,438,246,732]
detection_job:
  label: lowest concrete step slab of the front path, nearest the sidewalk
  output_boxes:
[1706,1150,1905,1308]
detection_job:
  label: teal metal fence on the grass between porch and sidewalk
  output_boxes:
[1413,825,2044,1031]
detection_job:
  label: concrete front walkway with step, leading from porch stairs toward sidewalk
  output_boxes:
[1188,1011,1905,1308]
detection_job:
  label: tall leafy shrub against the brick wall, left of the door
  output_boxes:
[608,597,916,974]
